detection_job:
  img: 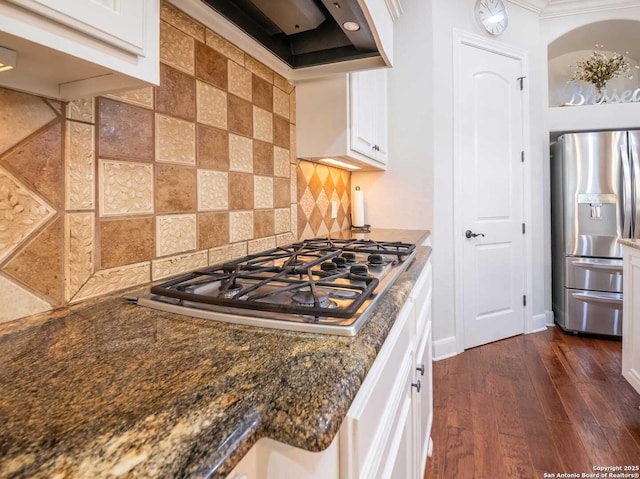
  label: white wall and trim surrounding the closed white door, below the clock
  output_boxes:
[432,0,550,354]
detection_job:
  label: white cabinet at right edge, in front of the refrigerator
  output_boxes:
[622,246,640,394]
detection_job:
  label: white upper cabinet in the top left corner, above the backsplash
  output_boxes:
[0,0,160,100]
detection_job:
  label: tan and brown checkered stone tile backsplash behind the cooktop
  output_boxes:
[0,3,350,322]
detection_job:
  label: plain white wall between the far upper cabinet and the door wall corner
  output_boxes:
[351,0,433,229]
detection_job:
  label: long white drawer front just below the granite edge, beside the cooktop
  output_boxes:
[340,301,413,479]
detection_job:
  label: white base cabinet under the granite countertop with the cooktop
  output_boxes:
[222,255,433,479]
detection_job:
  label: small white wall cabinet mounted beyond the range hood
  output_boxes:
[296,69,388,170]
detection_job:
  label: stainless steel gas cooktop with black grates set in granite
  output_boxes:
[137,238,415,336]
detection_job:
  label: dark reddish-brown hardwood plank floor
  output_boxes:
[425,328,640,479]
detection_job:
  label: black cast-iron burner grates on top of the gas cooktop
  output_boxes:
[146,238,415,318]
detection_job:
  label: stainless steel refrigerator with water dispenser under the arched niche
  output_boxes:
[551,131,640,337]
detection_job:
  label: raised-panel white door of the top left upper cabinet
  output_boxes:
[8,0,148,56]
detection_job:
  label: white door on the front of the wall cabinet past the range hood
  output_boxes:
[351,70,379,158]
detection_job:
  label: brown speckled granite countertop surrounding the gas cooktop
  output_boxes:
[0,231,431,478]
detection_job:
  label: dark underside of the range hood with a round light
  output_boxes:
[202,0,380,69]
